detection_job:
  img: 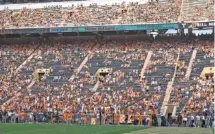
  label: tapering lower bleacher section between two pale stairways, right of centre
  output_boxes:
[145,49,177,110]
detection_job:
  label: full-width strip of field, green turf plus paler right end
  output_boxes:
[0,124,212,134]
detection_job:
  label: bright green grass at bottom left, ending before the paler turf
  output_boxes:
[0,124,144,134]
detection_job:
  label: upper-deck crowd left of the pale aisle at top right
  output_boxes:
[0,2,180,28]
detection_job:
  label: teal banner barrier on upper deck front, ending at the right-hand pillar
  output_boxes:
[0,23,179,34]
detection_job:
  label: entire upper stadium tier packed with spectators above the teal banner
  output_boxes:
[0,0,214,29]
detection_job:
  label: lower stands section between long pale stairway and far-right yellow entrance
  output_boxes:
[171,41,213,115]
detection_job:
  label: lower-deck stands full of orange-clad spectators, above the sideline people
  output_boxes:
[1,34,213,126]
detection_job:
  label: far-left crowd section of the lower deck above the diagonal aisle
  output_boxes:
[0,44,36,103]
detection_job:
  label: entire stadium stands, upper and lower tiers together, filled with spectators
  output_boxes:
[0,0,214,126]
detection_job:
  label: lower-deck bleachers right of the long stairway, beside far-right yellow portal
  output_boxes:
[170,42,214,114]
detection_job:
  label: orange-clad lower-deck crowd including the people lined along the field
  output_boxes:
[0,34,214,127]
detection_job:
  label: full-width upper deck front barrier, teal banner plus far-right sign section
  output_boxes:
[0,21,215,35]
